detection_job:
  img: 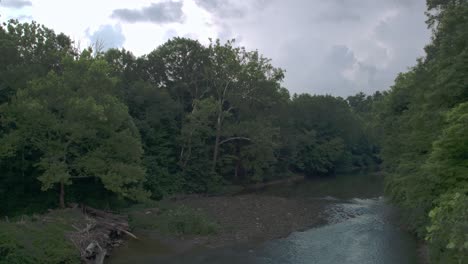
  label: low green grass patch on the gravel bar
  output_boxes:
[129,203,219,236]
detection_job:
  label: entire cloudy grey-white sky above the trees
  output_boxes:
[0,0,431,97]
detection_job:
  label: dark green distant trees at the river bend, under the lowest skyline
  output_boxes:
[288,94,373,176]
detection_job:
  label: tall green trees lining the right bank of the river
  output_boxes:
[370,0,468,263]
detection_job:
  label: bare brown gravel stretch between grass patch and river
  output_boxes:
[176,194,330,247]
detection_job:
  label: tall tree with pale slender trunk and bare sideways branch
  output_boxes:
[208,41,283,175]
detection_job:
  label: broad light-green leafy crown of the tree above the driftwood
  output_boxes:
[2,54,147,205]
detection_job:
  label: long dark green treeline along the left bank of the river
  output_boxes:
[0,20,376,215]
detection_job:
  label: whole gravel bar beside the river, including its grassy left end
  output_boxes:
[123,191,327,253]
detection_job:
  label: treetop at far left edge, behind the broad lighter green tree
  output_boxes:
[0,20,76,103]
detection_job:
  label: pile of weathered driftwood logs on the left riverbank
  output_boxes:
[68,204,138,264]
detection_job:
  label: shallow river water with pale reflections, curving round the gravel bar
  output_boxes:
[112,173,417,264]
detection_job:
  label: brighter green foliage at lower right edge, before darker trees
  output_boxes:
[423,103,468,263]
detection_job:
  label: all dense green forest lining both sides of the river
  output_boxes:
[0,0,468,263]
